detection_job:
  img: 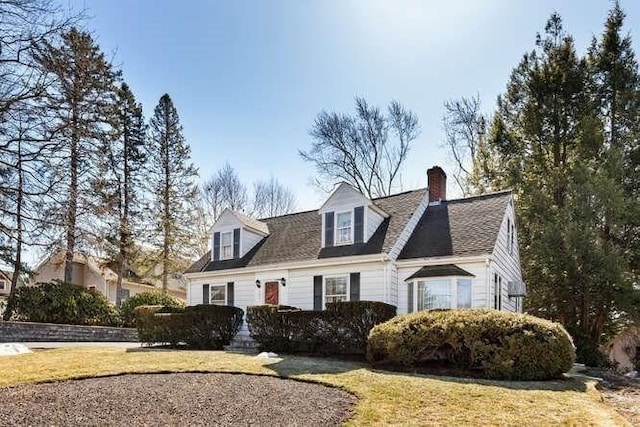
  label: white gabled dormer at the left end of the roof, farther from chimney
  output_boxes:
[211,209,269,261]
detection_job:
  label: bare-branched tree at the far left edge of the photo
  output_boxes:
[0,0,81,319]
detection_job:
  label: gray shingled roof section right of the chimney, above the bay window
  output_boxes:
[398,191,511,259]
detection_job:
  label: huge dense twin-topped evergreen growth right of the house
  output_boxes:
[472,5,638,363]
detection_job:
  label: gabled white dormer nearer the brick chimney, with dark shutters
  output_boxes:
[318,182,388,248]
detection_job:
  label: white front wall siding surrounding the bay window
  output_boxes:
[397,262,487,314]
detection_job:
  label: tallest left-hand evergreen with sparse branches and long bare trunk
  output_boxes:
[37,28,118,282]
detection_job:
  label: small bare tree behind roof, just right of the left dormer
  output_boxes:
[252,177,296,218]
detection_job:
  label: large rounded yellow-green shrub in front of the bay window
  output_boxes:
[367,309,575,380]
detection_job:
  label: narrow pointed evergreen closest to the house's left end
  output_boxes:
[147,94,198,293]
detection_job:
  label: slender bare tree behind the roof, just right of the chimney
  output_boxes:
[442,95,487,196]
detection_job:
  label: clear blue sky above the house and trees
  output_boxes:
[62,0,640,209]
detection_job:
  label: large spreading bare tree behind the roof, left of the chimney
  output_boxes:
[299,97,420,197]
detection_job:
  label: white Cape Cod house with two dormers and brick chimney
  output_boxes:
[185,166,525,320]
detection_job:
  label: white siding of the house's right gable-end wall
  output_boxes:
[489,199,523,311]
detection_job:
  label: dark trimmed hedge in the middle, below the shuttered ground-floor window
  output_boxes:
[247,301,396,355]
